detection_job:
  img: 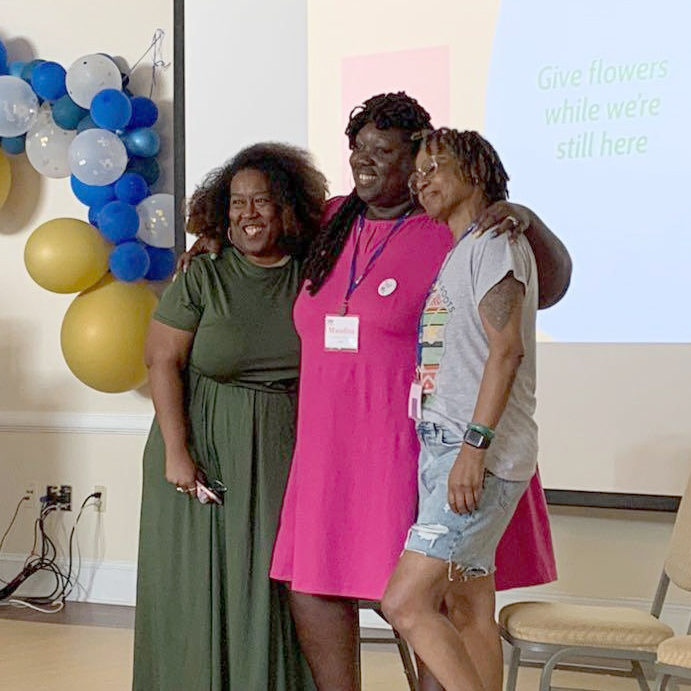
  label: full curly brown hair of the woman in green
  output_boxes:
[187,142,327,257]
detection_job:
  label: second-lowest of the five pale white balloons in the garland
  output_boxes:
[67,129,127,185]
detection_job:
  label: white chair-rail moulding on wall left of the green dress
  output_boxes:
[0,410,153,434]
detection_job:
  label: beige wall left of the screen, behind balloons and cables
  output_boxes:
[0,0,173,576]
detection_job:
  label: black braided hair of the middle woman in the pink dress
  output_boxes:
[303,91,432,295]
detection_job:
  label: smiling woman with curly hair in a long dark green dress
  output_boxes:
[133,144,326,691]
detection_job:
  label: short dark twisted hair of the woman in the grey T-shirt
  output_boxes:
[422,127,509,204]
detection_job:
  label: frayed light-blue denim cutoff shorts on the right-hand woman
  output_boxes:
[405,421,529,580]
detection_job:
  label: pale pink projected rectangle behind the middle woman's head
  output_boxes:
[340,46,451,189]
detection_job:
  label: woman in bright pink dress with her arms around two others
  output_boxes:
[271,93,571,691]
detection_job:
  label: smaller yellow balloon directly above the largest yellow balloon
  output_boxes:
[24,218,113,293]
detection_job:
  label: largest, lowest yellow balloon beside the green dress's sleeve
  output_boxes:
[60,274,158,393]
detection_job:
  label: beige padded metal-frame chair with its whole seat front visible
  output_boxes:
[499,480,691,691]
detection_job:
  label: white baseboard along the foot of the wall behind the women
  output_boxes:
[0,554,691,635]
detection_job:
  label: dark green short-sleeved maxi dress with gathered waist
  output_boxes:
[133,248,313,691]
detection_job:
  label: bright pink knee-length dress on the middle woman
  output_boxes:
[271,200,556,600]
